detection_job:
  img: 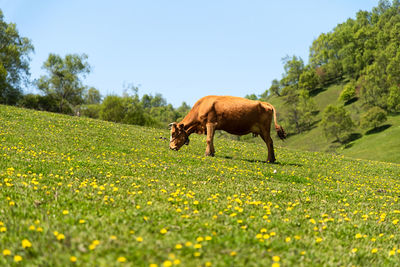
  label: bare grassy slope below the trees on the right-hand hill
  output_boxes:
[267,84,400,163]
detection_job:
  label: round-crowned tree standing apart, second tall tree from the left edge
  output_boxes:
[37,54,90,112]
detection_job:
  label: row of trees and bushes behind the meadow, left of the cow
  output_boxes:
[0,10,190,127]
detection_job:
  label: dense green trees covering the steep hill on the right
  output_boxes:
[247,0,400,141]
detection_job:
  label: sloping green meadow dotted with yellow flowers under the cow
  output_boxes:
[0,106,400,266]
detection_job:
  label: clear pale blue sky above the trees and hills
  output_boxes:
[0,0,378,107]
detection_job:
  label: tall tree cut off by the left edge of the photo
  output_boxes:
[0,10,33,105]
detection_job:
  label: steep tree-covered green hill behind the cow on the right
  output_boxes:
[256,0,400,163]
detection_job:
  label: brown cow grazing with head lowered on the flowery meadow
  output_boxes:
[169,96,286,162]
